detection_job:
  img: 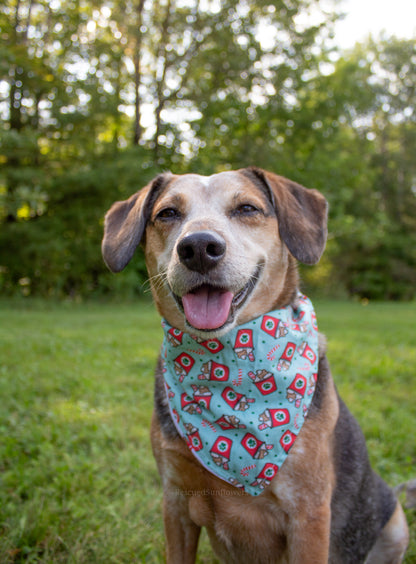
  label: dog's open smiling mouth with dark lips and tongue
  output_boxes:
[175,267,261,331]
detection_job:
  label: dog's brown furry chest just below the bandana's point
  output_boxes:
[161,426,311,564]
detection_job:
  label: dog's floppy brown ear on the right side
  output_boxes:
[245,168,328,264]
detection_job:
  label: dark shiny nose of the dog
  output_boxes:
[178,231,226,274]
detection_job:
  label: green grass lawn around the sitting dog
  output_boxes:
[0,301,416,564]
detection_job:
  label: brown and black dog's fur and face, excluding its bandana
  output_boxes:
[102,168,408,564]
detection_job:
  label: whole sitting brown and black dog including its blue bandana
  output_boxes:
[102,167,409,564]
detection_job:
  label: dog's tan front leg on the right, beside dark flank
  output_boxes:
[288,504,331,564]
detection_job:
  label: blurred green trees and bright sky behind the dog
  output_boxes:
[0,0,416,300]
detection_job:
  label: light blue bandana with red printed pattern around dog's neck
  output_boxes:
[162,296,318,496]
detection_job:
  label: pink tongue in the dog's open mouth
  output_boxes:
[182,287,234,329]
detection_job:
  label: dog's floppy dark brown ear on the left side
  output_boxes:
[101,174,172,272]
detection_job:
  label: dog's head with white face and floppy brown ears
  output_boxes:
[102,168,327,337]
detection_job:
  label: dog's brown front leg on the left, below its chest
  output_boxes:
[163,489,201,564]
